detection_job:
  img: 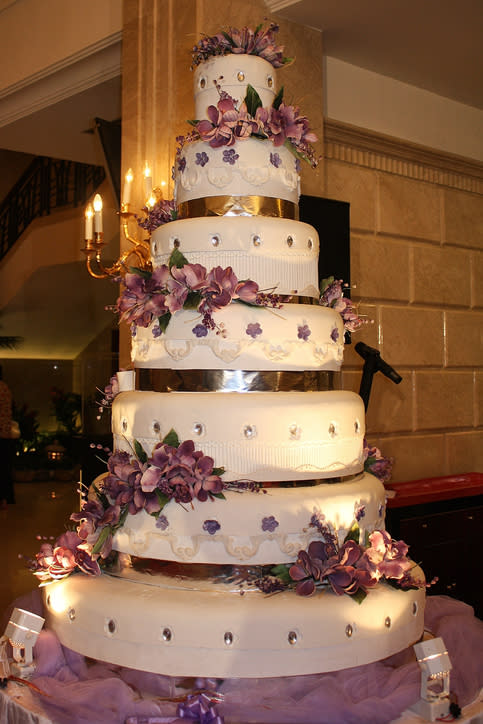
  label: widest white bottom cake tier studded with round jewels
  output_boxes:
[44,572,425,678]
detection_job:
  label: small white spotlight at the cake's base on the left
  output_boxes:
[0,608,45,679]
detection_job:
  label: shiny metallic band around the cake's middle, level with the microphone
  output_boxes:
[136,367,338,392]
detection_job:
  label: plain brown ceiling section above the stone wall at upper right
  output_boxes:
[266,0,483,108]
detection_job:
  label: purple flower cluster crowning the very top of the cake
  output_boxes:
[192,23,291,68]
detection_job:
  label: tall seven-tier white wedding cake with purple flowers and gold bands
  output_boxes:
[37,22,424,677]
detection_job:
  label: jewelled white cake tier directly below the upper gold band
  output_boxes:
[151,216,319,298]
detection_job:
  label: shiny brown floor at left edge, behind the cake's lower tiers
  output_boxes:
[0,481,79,619]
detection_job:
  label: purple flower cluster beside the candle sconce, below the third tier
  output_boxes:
[117,256,281,337]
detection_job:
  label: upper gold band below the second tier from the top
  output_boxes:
[178,196,298,220]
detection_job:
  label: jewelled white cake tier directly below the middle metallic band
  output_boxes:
[112,390,365,482]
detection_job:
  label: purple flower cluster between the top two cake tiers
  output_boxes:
[195,94,317,168]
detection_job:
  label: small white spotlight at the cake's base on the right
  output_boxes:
[411,638,453,721]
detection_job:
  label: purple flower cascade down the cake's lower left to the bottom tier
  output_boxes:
[33,433,223,581]
